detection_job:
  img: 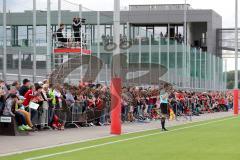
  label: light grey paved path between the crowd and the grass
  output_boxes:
[0,112,233,156]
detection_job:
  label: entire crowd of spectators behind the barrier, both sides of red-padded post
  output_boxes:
[0,79,233,131]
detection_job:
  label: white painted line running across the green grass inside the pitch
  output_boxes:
[24,117,237,160]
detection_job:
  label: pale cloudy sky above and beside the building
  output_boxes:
[0,0,240,70]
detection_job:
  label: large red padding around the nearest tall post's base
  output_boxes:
[111,78,122,135]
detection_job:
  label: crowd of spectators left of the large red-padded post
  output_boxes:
[0,79,110,130]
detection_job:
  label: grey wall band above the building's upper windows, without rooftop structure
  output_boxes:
[0,10,220,27]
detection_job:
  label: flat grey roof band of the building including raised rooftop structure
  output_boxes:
[0,4,222,26]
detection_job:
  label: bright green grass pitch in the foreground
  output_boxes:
[0,117,240,160]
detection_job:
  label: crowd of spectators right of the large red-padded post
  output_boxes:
[122,87,233,121]
